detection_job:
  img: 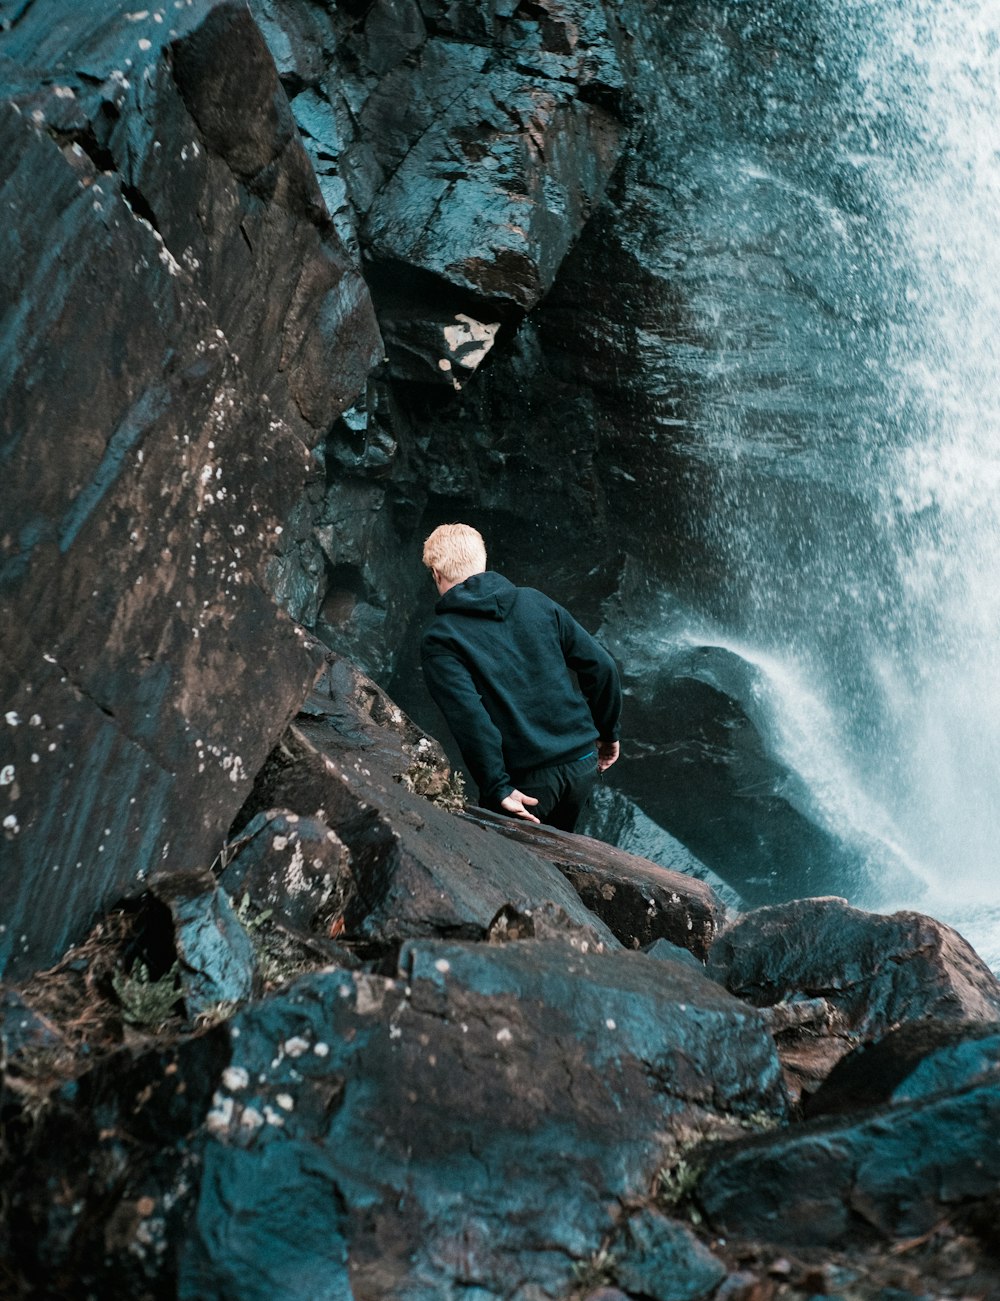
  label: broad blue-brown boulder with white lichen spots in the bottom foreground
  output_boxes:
[5,941,783,1301]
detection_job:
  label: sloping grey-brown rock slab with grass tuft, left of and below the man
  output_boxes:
[234,656,618,948]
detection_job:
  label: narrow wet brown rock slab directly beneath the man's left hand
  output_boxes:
[464,808,724,959]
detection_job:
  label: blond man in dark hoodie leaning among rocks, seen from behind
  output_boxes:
[421,524,622,831]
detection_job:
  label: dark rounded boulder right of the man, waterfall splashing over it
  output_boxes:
[585,614,919,905]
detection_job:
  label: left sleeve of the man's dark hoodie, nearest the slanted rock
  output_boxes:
[421,648,514,809]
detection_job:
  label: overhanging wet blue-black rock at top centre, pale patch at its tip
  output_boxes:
[252,0,625,346]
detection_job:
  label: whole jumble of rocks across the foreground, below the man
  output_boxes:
[0,656,1000,1301]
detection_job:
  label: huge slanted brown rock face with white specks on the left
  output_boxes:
[0,0,380,971]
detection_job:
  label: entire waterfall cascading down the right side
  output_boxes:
[647,0,1000,961]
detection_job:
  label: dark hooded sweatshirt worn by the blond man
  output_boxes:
[420,571,622,808]
